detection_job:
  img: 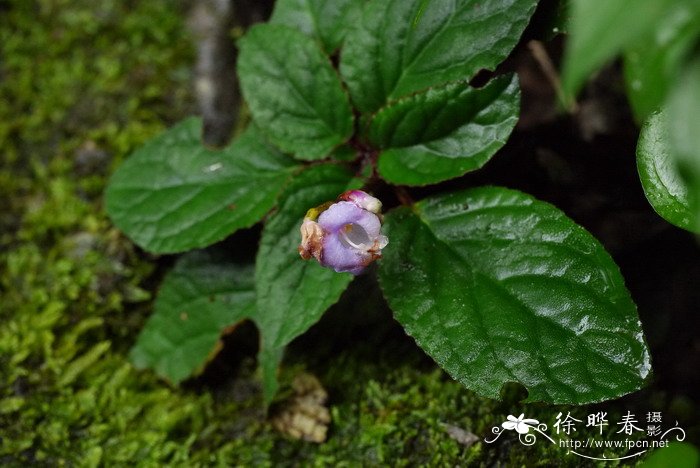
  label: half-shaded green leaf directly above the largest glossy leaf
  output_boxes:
[369,76,520,185]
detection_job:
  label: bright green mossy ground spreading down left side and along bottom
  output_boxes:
[0,0,690,466]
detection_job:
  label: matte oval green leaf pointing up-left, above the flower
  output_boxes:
[238,24,353,160]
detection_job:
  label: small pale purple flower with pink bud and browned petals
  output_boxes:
[299,190,389,275]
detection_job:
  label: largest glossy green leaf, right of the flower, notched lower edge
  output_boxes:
[379,187,650,404]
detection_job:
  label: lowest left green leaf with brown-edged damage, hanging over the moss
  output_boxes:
[130,251,256,383]
